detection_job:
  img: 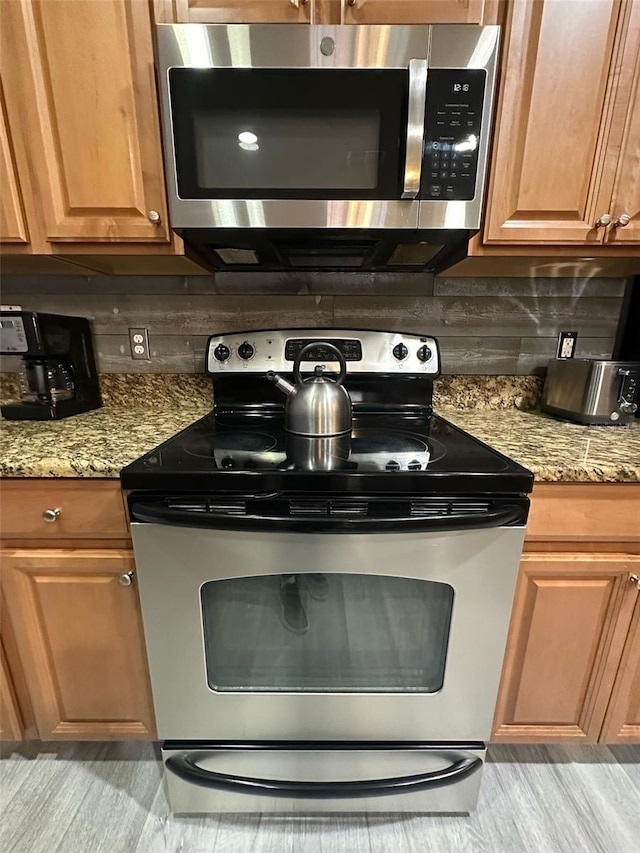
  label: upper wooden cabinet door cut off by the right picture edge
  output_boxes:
[606,0,640,246]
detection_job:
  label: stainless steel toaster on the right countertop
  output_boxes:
[542,358,640,425]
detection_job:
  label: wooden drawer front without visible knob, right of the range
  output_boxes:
[526,483,640,542]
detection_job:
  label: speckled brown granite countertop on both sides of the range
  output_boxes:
[0,375,640,482]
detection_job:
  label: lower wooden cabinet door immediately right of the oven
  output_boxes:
[493,553,640,743]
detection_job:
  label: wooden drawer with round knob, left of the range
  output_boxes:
[0,479,129,539]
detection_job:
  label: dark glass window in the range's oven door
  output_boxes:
[200,574,454,693]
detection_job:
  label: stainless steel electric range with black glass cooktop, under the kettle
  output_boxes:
[121,329,533,813]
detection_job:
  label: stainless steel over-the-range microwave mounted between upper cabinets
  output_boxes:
[156,24,500,270]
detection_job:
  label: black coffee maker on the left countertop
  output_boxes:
[0,311,102,421]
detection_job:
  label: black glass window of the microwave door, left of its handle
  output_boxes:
[169,68,408,199]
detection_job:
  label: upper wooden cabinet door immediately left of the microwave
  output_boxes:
[0,0,169,248]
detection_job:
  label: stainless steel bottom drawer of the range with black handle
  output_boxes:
[162,741,486,814]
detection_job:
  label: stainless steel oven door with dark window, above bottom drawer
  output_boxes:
[131,507,524,741]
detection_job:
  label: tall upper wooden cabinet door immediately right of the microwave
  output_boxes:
[483,0,621,244]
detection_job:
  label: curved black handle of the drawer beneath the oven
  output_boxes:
[166,752,482,800]
